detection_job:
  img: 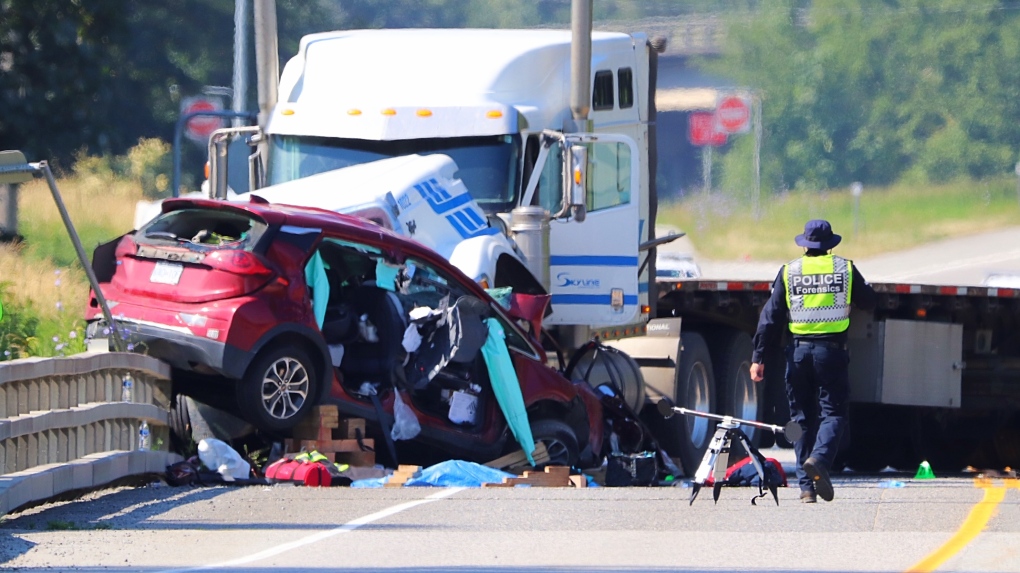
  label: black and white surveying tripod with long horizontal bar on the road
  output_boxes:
[658,398,804,506]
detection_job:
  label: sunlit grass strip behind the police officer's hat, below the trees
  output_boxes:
[658,178,1020,261]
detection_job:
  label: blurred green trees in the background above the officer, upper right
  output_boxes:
[704,0,1020,189]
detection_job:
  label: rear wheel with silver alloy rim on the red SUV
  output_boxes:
[237,345,318,435]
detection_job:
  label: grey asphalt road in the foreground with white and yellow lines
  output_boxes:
[0,466,1020,573]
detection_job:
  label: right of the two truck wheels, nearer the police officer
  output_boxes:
[712,329,765,464]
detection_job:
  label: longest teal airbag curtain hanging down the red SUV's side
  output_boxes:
[481,318,534,466]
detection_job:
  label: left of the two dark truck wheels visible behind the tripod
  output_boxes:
[660,332,716,475]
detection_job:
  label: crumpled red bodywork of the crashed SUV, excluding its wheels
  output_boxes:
[86,199,603,460]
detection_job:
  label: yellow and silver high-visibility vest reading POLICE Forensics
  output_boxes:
[782,255,854,334]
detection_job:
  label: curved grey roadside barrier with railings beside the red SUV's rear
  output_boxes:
[0,353,180,515]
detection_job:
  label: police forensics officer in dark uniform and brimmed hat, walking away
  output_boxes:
[751,219,877,503]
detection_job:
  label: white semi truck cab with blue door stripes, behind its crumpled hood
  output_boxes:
[225,30,654,334]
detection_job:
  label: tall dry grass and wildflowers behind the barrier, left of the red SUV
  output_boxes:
[0,140,170,360]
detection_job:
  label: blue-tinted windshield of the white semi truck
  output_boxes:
[267,135,520,213]
